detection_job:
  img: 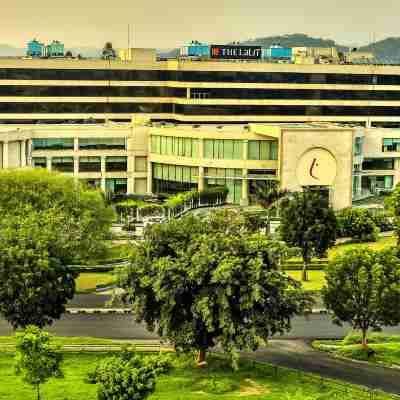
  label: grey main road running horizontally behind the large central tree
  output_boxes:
[0,314,400,339]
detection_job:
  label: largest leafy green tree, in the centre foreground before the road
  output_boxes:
[120,211,309,365]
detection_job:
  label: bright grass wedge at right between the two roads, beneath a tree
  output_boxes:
[313,333,400,368]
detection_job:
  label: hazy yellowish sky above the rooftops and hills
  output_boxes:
[0,0,400,48]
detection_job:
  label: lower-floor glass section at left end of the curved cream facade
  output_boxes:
[152,163,199,193]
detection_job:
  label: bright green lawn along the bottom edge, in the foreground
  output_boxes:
[0,353,392,400]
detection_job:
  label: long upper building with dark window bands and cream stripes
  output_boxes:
[0,49,400,126]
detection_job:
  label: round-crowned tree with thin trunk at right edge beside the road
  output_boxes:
[322,247,400,348]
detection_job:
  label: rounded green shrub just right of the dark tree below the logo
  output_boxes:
[336,208,379,242]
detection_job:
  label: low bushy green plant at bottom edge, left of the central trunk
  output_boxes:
[91,355,170,400]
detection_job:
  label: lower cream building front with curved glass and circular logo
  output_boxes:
[0,120,400,209]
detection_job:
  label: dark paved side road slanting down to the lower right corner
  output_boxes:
[242,340,400,394]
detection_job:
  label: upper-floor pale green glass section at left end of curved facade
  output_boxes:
[151,135,199,158]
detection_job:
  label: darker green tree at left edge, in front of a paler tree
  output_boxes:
[0,207,77,328]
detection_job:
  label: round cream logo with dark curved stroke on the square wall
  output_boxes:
[296,148,337,186]
